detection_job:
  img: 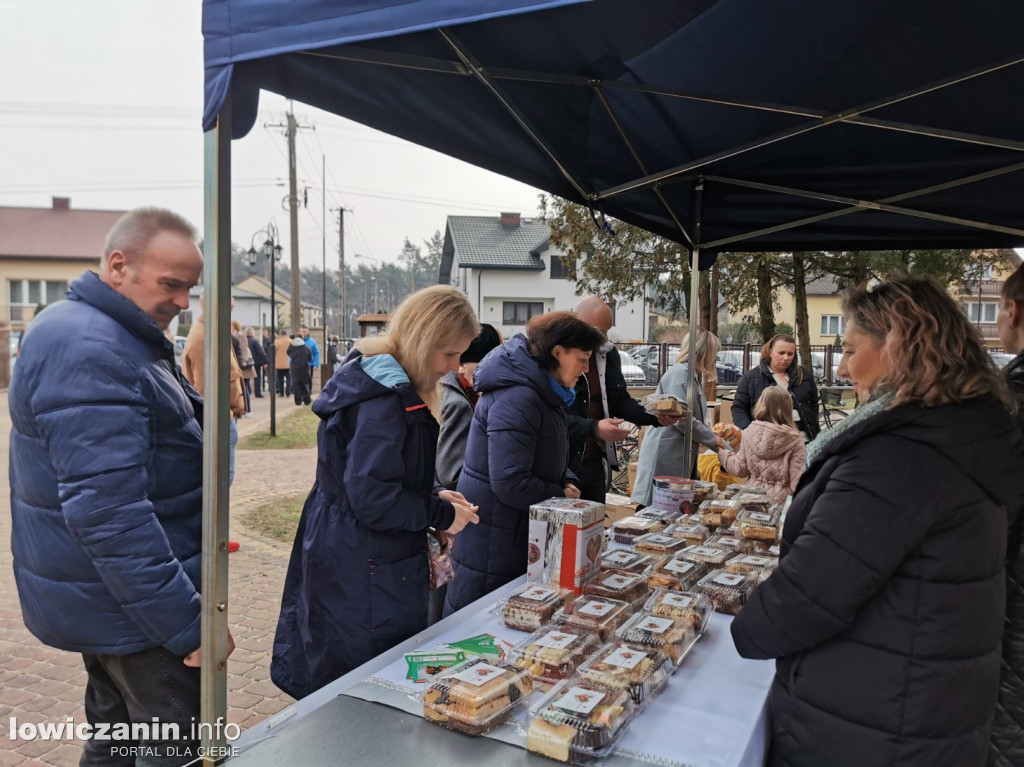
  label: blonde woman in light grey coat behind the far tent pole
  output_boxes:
[633,330,725,506]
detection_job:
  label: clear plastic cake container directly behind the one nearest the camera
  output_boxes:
[580,642,674,713]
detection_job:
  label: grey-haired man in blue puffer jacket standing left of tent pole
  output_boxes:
[10,208,230,765]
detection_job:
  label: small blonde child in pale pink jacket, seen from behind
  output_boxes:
[718,386,807,505]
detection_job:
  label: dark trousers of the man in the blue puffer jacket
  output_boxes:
[79,647,200,767]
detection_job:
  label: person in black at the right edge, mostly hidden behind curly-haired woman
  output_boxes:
[988,266,1024,767]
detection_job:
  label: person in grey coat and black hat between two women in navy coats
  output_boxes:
[427,324,502,626]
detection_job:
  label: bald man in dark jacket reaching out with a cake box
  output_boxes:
[565,296,679,503]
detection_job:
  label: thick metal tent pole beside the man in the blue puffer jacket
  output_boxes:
[200,95,231,753]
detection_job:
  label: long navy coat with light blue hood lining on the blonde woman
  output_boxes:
[270,351,455,697]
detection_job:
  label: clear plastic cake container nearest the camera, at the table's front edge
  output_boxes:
[526,676,635,764]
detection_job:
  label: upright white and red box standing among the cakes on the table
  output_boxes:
[526,498,605,594]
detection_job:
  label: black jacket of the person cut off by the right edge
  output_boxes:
[988,353,1024,767]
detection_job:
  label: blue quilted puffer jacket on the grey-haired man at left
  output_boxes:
[9,271,203,655]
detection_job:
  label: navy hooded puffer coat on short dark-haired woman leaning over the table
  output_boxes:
[444,334,575,614]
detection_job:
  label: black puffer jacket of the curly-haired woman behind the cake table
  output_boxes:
[732,400,1024,767]
